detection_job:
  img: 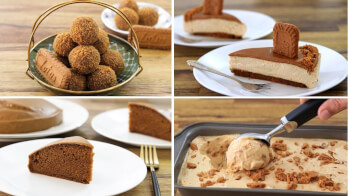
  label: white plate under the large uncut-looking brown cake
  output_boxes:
[0,99,89,141]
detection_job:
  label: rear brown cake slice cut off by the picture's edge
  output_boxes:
[128,103,171,141]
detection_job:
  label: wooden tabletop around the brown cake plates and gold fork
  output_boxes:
[0,99,172,196]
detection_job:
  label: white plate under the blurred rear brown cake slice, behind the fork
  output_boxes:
[91,108,171,149]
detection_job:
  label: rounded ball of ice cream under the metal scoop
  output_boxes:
[226,138,272,172]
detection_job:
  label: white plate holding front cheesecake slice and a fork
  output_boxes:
[193,40,347,97]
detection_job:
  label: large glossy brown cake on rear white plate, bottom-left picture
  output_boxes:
[0,99,62,133]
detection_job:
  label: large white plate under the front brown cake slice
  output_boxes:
[0,138,147,196]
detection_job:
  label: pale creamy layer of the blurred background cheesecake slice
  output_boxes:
[184,18,246,36]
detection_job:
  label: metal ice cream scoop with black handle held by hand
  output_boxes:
[236,99,327,146]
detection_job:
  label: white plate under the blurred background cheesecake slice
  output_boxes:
[174,9,276,48]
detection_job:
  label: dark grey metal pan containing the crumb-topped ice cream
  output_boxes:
[174,122,347,196]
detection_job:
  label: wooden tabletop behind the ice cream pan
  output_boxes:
[173,99,347,196]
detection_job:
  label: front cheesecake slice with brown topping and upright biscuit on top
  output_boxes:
[229,23,320,88]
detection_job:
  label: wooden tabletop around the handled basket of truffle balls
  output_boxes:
[0,0,172,96]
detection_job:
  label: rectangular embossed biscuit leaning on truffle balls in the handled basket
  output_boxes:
[35,48,72,89]
